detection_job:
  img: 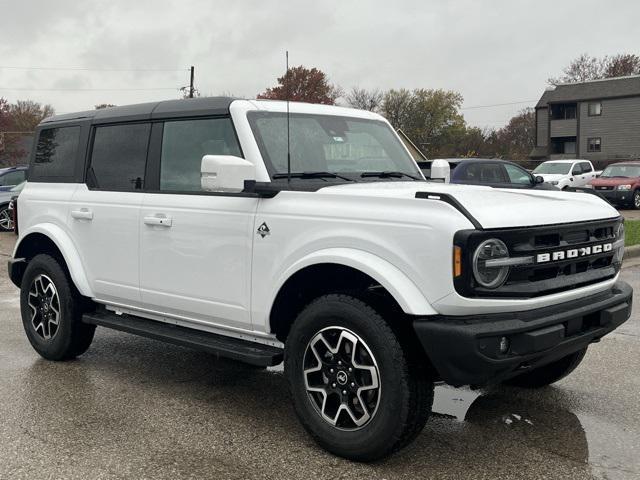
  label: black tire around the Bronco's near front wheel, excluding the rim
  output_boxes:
[285,294,433,461]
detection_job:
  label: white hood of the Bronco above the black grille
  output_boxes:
[318,182,620,228]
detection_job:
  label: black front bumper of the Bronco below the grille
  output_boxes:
[413,281,633,386]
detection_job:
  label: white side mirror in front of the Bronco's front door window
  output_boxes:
[200,155,256,192]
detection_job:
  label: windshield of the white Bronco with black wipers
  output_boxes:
[248,112,422,180]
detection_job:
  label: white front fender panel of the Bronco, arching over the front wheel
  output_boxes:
[252,191,472,331]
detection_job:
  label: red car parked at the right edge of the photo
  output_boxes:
[590,162,640,210]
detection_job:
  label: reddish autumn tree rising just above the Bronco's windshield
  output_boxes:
[258,65,342,105]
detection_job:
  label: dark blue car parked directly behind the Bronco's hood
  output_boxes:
[447,158,558,190]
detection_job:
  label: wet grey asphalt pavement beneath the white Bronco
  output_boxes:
[0,234,640,480]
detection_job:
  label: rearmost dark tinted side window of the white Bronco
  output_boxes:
[30,127,80,181]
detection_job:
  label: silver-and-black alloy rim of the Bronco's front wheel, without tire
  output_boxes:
[303,326,380,430]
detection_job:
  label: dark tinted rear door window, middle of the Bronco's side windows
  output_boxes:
[87,123,151,192]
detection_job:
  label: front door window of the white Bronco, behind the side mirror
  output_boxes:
[160,118,241,192]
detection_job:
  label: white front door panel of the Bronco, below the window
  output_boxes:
[140,193,258,329]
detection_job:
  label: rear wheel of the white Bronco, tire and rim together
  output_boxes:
[20,255,95,360]
